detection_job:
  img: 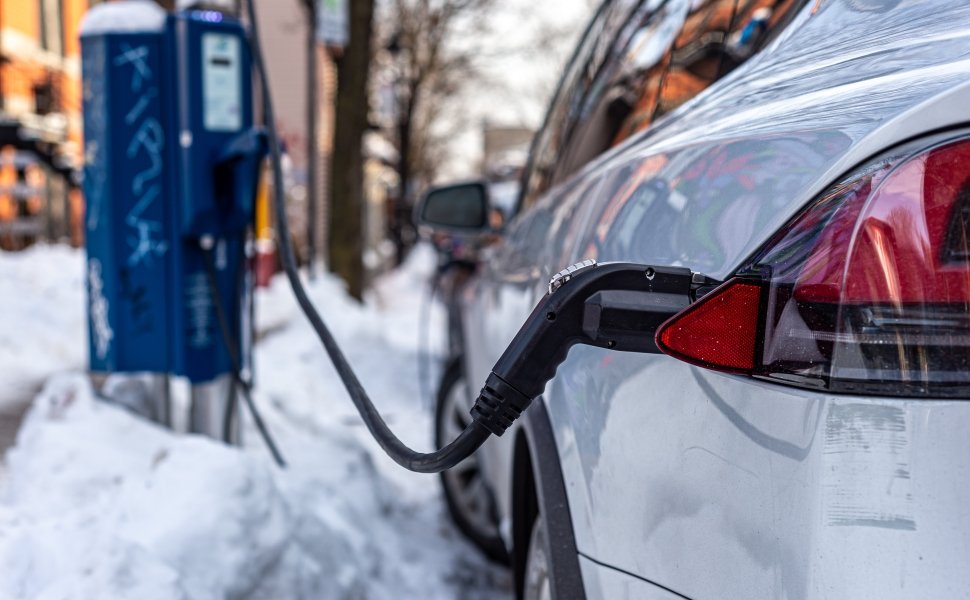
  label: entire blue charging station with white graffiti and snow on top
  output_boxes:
[81,0,266,383]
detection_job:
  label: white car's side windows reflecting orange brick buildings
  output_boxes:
[523,0,805,212]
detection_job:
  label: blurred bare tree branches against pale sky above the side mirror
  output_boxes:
[379,0,577,188]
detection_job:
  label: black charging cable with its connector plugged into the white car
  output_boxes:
[240,0,708,473]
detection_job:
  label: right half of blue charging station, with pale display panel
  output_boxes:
[167,17,262,383]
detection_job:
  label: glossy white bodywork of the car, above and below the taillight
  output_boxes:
[456,0,970,600]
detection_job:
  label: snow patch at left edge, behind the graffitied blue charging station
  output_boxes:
[0,246,87,409]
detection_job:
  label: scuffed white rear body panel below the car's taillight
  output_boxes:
[548,349,970,599]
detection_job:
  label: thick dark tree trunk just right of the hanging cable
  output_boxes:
[328,0,374,300]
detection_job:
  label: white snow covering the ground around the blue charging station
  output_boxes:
[0,247,510,599]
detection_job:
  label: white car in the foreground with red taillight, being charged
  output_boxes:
[416,0,970,600]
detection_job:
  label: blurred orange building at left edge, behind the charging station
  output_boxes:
[0,0,92,249]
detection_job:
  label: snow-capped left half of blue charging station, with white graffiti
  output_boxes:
[81,2,174,372]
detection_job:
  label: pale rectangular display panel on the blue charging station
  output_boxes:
[202,33,243,131]
